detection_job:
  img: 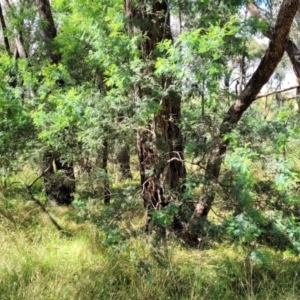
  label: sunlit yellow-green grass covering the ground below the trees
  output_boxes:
[0,200,300,300]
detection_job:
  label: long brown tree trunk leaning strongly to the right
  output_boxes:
[194,0,298,227]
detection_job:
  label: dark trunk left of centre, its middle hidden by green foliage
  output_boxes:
[38,0,75,205]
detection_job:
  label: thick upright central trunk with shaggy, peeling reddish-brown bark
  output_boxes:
[124,0,186,232]
